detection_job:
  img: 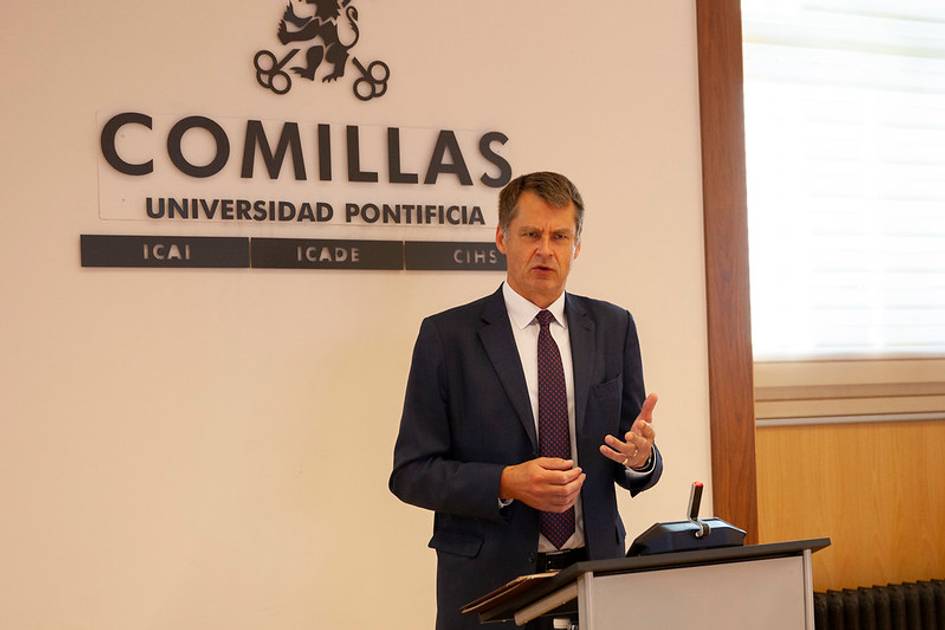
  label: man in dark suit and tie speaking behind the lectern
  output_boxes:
[390,172,662,630]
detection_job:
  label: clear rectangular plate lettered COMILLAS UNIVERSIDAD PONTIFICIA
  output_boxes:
[99,112,512,228]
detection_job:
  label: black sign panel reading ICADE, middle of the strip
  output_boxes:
[251,238,404,269]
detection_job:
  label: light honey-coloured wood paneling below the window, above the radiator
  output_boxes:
[757,422,945,590]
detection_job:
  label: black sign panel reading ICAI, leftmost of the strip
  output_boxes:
[80,234,249,267]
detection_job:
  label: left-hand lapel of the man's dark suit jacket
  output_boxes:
[479,287,538,449]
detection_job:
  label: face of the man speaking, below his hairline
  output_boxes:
[495,190,581,308]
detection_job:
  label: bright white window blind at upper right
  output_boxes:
[742,0,945,361]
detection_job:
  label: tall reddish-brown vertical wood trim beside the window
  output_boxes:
[696,0,758,542]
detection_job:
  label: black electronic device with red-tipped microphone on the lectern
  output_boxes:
[627,481,745,556]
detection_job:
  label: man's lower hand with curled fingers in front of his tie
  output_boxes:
[499,457,587,512]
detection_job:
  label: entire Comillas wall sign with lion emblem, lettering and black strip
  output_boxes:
[90,0,512,270]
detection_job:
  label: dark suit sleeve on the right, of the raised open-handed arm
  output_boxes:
[615,312,663,496]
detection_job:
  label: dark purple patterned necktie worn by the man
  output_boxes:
[535,311,574,549]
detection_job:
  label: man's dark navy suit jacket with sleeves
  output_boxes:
[390,287,662,630]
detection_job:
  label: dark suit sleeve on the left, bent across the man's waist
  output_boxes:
[389,318,503,520]
